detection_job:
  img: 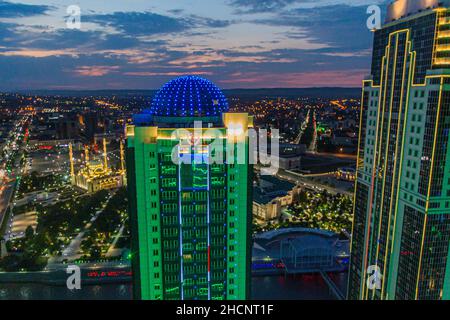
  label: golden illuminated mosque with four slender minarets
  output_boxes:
[69,139,126,193]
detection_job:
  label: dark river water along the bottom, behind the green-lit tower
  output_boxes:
[0,273,347,300]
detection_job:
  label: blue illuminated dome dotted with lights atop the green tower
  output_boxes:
[149,76,228,117]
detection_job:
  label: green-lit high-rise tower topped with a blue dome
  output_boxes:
[127,76,253,300]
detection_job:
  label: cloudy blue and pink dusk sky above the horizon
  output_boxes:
[0,0,388,91]
